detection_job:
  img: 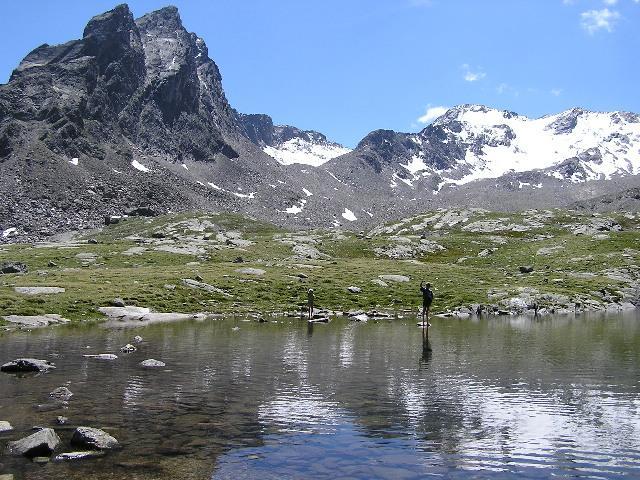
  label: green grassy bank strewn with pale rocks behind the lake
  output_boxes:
[0,209,640,322]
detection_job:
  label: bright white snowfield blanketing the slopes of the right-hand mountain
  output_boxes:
[424,105,640,185]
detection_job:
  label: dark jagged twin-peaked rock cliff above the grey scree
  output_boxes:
[0,5,238,165]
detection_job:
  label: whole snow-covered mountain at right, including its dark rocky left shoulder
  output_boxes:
[328,105,640,194]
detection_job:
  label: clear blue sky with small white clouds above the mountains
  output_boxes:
[0,0,640,146]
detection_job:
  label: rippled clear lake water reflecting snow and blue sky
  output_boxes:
[0,313,640,479]
